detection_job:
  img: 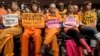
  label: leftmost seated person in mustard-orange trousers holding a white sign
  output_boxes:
[0,2,22,56]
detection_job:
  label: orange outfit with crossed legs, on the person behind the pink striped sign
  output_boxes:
[44,13,62,56]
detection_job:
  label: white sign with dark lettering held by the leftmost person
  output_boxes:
[3,14,18,27]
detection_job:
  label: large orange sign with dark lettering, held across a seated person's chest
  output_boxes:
[22,13,45,28]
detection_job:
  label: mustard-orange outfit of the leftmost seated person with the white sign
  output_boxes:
[0,12,22,56]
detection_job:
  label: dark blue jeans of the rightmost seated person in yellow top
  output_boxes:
[80,27,98,48]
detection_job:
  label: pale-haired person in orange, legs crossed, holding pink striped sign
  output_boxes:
[42,4,62,56]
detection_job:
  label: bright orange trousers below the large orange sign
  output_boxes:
[21,12,42,56]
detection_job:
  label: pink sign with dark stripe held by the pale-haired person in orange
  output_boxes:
[46,19,61,28]
